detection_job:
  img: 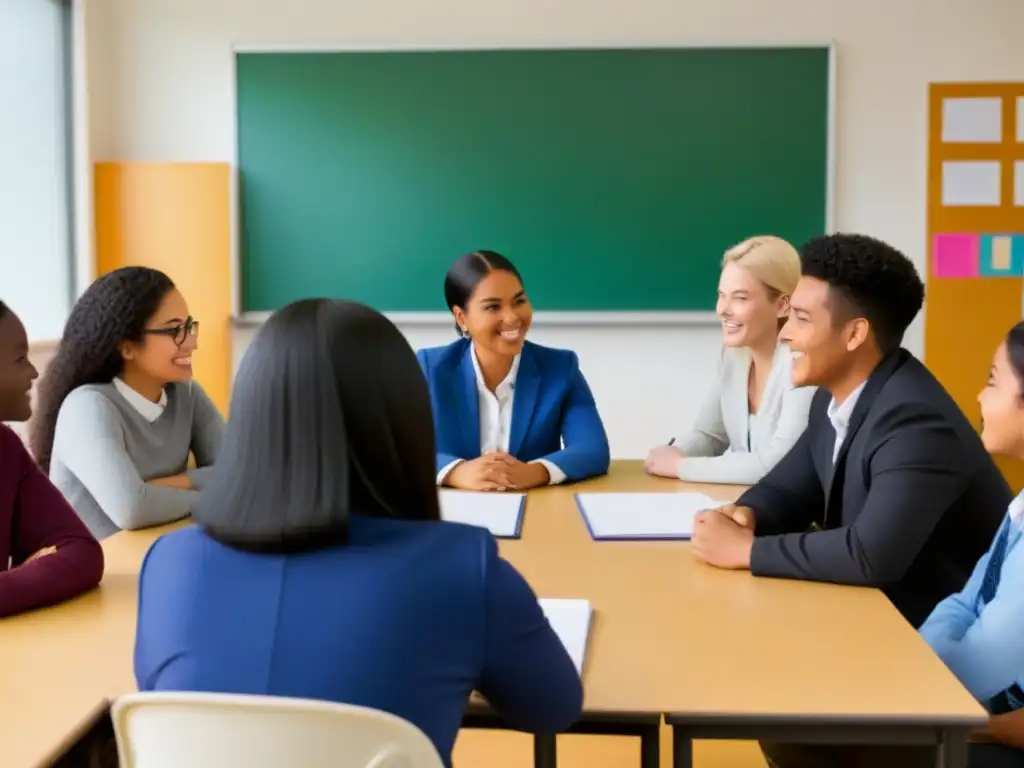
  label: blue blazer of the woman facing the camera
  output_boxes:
[416,339,611,480]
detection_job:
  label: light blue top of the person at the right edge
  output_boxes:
[921,493,1024,709]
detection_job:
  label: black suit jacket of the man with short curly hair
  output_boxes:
[737,349,1013,627]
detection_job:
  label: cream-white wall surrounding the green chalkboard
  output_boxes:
[81,0,1024,457]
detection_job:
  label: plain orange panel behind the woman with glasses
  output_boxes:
[93,163,232,413]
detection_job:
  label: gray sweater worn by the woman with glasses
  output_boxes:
[50,382,223,539]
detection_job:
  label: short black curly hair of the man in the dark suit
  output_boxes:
[800,233,925,354]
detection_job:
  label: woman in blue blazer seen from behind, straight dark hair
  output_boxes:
[135,300,583,762]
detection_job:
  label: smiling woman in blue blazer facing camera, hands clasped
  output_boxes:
[417,251,610,490]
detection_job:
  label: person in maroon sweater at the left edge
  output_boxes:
[0,301,103,618]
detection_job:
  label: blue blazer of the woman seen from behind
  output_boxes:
[135,516,583,763]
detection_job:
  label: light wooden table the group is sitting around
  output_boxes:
[0,462,985,768]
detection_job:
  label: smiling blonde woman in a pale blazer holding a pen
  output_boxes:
[645,236,814,484]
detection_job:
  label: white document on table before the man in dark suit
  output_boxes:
[577,493,724,540]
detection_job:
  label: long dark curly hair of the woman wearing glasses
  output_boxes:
[29,266,174,472]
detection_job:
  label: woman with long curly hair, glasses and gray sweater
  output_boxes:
[30,266,223,539]
